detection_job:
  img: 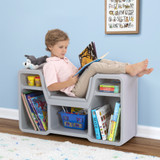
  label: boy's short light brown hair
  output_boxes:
[45,29,69,51]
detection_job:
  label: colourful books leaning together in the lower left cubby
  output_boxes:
[21,91,48,131]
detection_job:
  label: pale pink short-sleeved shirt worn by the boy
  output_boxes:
[43,57,78,96]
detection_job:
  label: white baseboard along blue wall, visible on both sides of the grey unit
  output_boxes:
[0,108,160,140]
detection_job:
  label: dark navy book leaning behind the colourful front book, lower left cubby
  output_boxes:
[25,91,45,131]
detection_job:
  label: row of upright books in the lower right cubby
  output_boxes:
[92,102,121,141]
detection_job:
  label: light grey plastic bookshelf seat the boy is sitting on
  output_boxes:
[18,69,138,146]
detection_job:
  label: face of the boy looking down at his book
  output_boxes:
[48,40,69,58]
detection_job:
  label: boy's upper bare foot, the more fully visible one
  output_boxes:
[126,59,148,76]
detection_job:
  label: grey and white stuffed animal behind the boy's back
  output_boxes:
[23,55,48,69]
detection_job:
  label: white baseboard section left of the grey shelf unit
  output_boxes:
[0,108,19,120]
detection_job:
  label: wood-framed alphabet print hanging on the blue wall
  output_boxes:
[105,0,139,34]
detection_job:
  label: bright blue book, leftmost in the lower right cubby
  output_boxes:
[91,109,101,139]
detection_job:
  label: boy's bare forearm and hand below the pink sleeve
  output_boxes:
[47,76,78,91]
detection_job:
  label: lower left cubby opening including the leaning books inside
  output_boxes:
[20,89,48,132]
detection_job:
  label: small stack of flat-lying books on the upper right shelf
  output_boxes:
[99,83,119,93]
